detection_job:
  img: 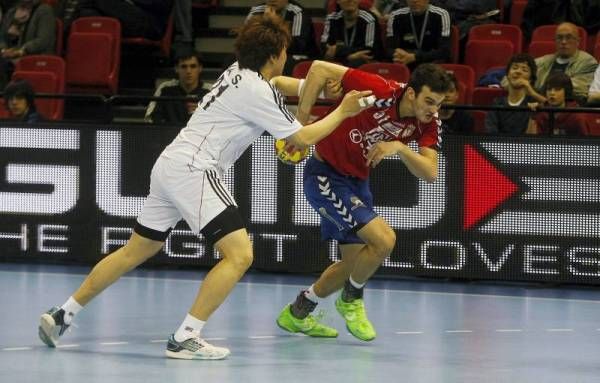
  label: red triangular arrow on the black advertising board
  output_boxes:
[463,145,518,230]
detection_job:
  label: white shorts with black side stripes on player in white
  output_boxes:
[137,157,237,237]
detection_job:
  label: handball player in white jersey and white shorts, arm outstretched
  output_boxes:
[39,15,371,359]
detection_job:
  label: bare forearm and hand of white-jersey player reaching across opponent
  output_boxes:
[286,90,372,148]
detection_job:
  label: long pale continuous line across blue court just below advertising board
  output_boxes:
[0,270,600,304]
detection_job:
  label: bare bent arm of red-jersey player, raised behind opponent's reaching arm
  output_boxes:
[296,60,348,124]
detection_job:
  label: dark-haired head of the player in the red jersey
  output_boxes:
[406,64,452,123]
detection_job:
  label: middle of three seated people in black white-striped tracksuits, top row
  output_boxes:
[321,0,383,67]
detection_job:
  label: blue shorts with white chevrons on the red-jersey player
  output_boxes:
[304,157,377,244]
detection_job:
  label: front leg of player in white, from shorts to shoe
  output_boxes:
[166,170,247,359]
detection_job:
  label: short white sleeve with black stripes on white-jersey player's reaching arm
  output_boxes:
[239,82,302,139]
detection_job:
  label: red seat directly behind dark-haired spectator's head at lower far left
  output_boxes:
[12,71,62,120]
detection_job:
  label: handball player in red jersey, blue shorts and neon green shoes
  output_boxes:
[277,61,450,341]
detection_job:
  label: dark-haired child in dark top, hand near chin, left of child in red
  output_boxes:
[485,53,545,135]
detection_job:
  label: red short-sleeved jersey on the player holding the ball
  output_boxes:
[316,69,441,179]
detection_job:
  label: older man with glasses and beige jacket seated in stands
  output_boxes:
[535,23,598,100]
